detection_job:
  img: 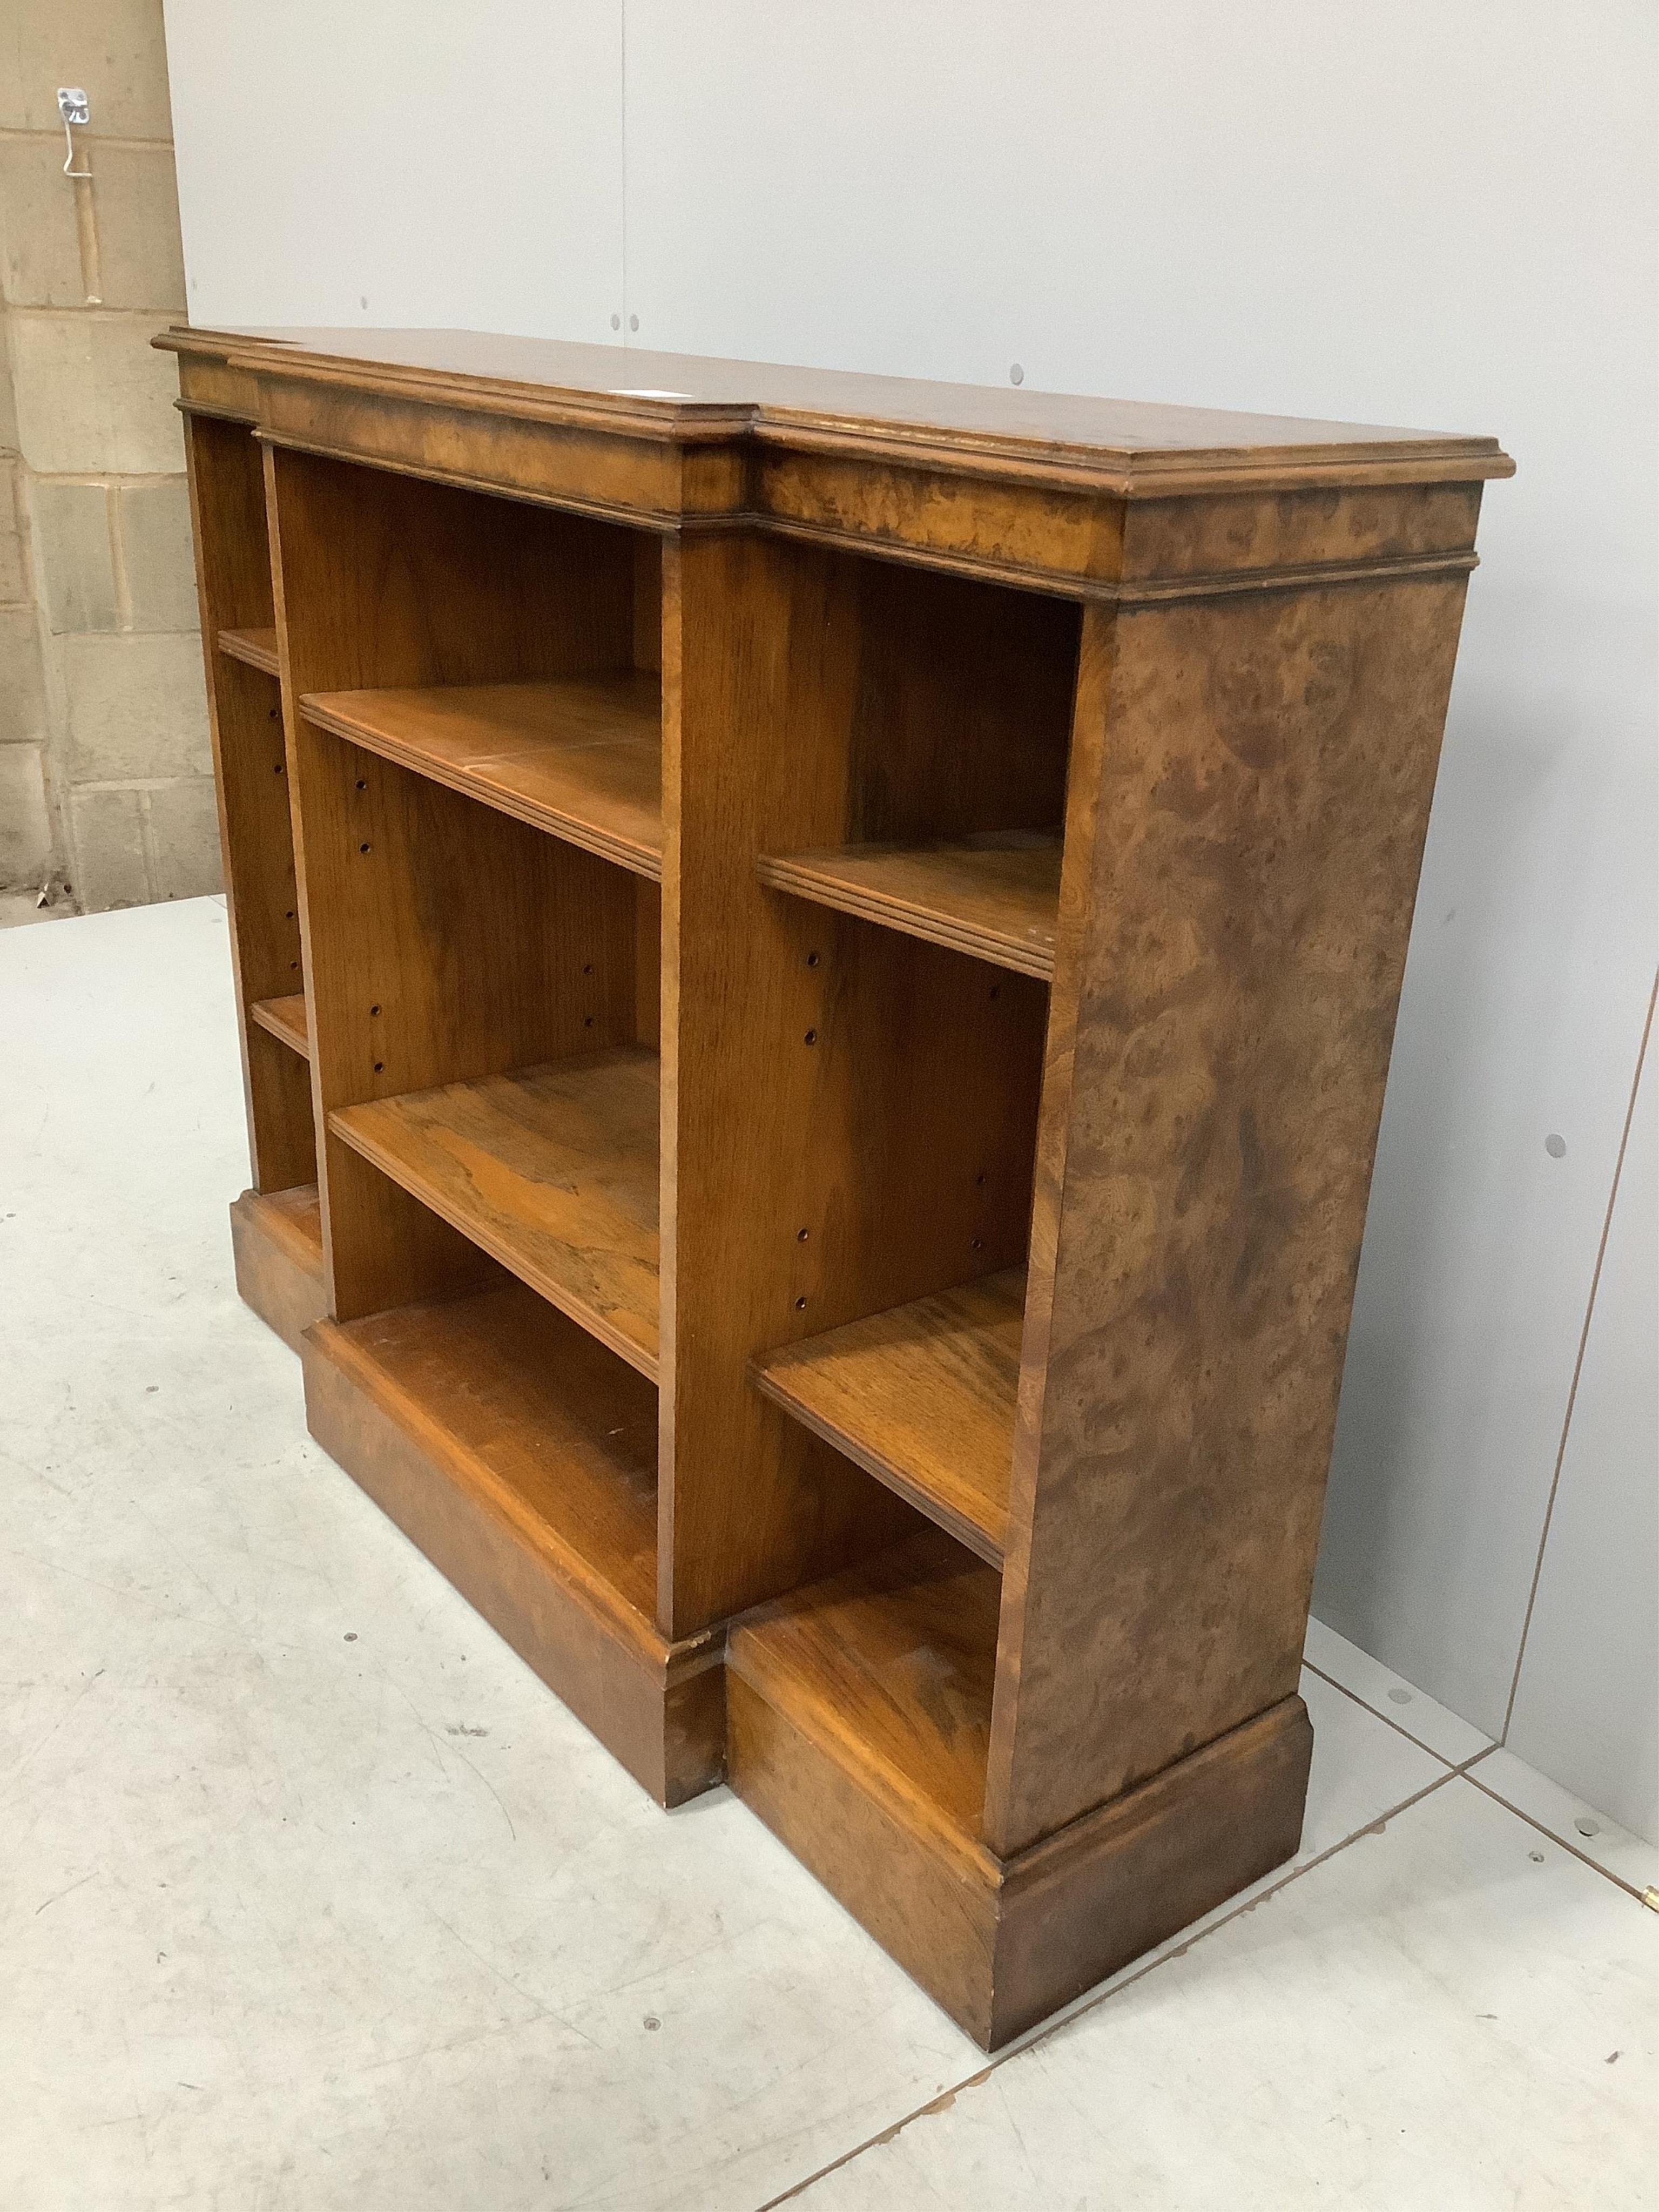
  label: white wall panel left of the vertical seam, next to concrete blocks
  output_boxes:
[166,0,622,343]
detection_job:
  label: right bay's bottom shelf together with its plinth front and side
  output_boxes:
[725,1530,1314,2051]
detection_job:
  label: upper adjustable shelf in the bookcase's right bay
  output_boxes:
[757,830,1060,982]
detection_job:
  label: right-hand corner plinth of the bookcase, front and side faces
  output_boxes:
[728,1672,1314,2051]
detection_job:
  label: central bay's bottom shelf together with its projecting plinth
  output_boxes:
[303,1278,725,1805]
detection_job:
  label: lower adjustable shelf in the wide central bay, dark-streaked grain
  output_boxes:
[327,1044,659,1382]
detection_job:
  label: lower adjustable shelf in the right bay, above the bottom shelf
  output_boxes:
[754,1267,1027,1566]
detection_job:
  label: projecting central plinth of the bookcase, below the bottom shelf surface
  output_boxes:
[301,1320,725,1805]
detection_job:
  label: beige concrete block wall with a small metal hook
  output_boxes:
[0,0,219,912]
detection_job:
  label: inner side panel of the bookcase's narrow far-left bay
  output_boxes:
[186,414,316,1192]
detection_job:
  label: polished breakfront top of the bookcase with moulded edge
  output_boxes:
[157,327,1513,480]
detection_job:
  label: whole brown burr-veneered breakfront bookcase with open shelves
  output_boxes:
[159,329,1511,2048]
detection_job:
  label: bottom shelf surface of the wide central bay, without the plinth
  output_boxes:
[329,1281,657,1635]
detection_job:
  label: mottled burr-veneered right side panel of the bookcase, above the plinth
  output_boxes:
[987,579,1462,1856]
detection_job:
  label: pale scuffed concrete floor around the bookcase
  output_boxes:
[0,900,1659,2212]
